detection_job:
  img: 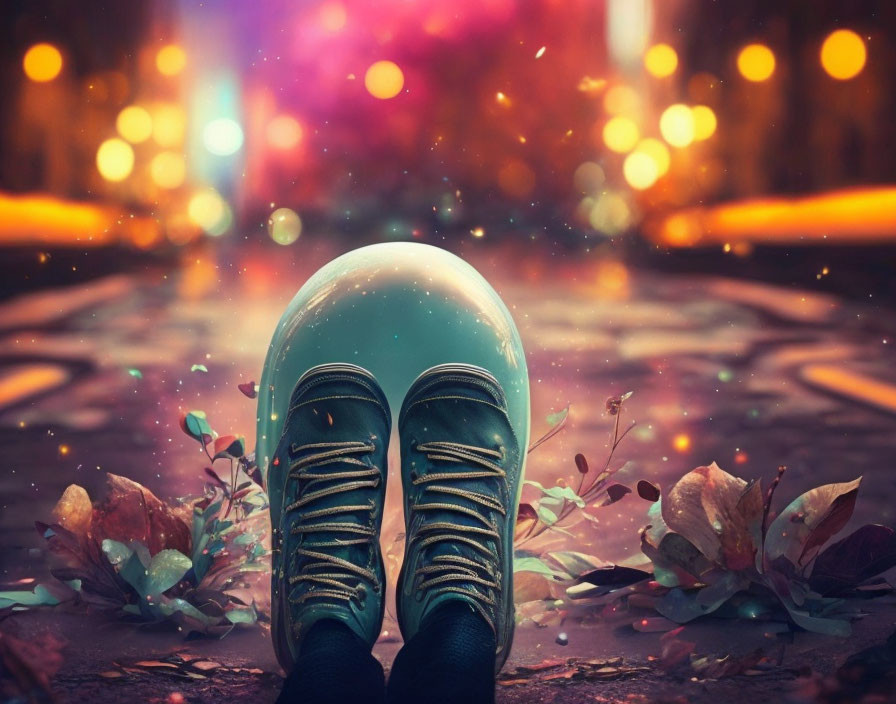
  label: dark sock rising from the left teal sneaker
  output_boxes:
[277,619,385,704]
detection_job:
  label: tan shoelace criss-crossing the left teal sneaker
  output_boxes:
[284,441,381,603]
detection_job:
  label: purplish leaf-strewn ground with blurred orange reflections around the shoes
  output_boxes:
[0,241,896,702]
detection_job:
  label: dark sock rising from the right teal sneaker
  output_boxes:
[387,600,495,704]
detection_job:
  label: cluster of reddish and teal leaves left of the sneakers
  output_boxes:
[0,411,269,636]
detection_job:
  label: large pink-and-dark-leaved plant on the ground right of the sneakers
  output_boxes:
[568,463,896,636]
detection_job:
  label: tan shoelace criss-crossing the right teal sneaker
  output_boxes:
[411,441,507,629]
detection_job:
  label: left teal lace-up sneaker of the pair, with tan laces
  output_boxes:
[267,364,392,673]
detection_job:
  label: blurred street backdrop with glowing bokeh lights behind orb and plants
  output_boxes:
[0,0,896,576]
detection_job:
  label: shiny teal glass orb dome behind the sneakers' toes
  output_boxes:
[257,242,529,484]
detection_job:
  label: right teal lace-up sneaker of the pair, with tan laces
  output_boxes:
[397,364,522,672]
